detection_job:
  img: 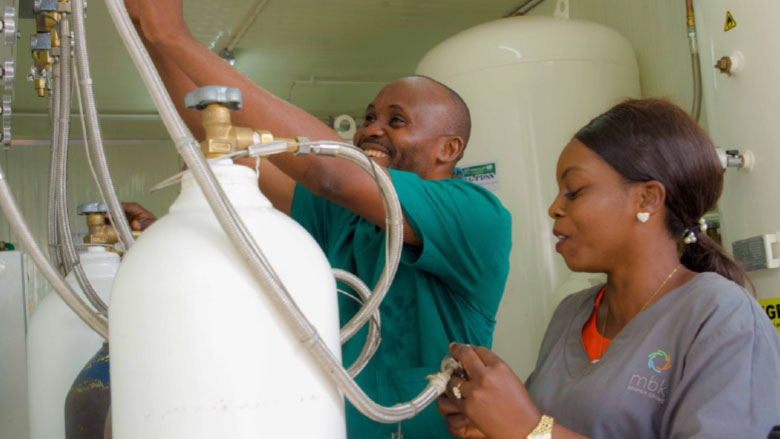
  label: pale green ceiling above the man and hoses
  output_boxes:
[14,0,532,136]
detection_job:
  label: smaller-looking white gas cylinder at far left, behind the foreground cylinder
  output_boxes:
[27,247,119,439]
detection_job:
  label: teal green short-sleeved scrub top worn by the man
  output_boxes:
[291,170,512,439]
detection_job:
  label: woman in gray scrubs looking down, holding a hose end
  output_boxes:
[438,100,780,439]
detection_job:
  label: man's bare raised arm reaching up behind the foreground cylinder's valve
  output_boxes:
[125,0,419,243]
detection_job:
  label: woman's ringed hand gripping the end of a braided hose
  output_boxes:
[437,343,541,438]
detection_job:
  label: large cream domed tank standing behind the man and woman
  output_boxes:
[417,17,639,376]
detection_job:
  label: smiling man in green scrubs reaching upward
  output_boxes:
[126,0,511,439]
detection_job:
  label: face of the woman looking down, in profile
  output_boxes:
[549,139,639,272]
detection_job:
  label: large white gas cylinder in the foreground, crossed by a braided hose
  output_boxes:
[109,161,346,439]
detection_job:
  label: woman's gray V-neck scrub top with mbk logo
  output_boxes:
[526,273,780,439]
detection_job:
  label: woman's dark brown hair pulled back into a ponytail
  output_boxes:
[574,99,750,287]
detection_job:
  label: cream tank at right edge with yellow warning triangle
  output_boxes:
[694,0,780,303]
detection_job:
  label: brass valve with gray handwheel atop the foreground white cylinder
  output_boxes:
[185,86,294,158]
